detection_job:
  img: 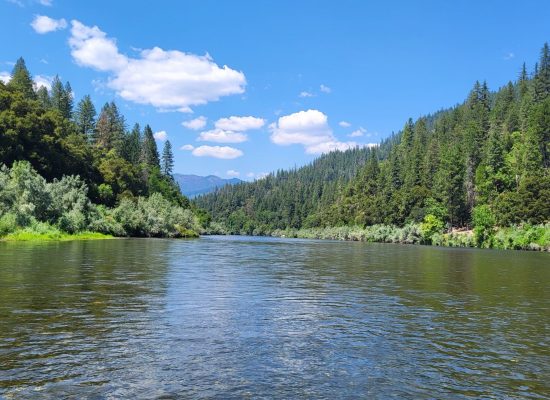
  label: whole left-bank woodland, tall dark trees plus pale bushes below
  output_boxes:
[0,58,203,237]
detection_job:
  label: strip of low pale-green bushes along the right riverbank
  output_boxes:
[270,223,550,251]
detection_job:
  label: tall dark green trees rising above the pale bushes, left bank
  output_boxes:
[0,58,183,207]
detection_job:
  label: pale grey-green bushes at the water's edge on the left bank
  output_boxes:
[0,161,200,240]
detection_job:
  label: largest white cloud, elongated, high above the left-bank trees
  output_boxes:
[69,20,246,111]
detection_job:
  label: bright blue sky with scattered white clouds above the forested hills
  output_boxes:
[0,0,550,180]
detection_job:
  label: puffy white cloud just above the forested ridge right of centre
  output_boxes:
[269,110,358,154]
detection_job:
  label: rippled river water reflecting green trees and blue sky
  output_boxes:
[0,237,550,399]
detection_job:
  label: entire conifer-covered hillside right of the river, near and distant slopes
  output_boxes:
[195,44,550,247]
